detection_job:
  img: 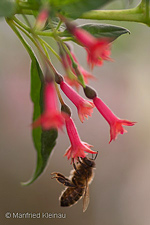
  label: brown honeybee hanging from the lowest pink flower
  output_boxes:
[51,153,97,212]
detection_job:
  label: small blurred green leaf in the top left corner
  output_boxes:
[0,0,15,17]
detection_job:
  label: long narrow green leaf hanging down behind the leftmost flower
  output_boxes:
[23,49,57,185]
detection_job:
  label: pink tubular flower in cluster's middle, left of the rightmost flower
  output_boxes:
[60,81,94,123]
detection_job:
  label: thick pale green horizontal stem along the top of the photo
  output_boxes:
[16,0,150,26]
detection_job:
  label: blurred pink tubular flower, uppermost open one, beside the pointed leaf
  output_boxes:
[72,27,111,68]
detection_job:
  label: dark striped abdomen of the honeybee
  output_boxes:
[60,187,84,207]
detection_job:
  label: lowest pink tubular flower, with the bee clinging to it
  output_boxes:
[65,117,96,161]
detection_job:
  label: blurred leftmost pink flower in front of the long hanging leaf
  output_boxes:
[32,82,64,130]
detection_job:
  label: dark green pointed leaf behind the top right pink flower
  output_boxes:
[60,23,130,41]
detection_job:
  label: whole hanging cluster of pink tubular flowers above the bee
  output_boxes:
[32,16,135,162]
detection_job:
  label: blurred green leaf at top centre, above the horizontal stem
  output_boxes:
[49,0,112,19]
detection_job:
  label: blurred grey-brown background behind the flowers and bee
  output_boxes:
[0,0,150,225]
